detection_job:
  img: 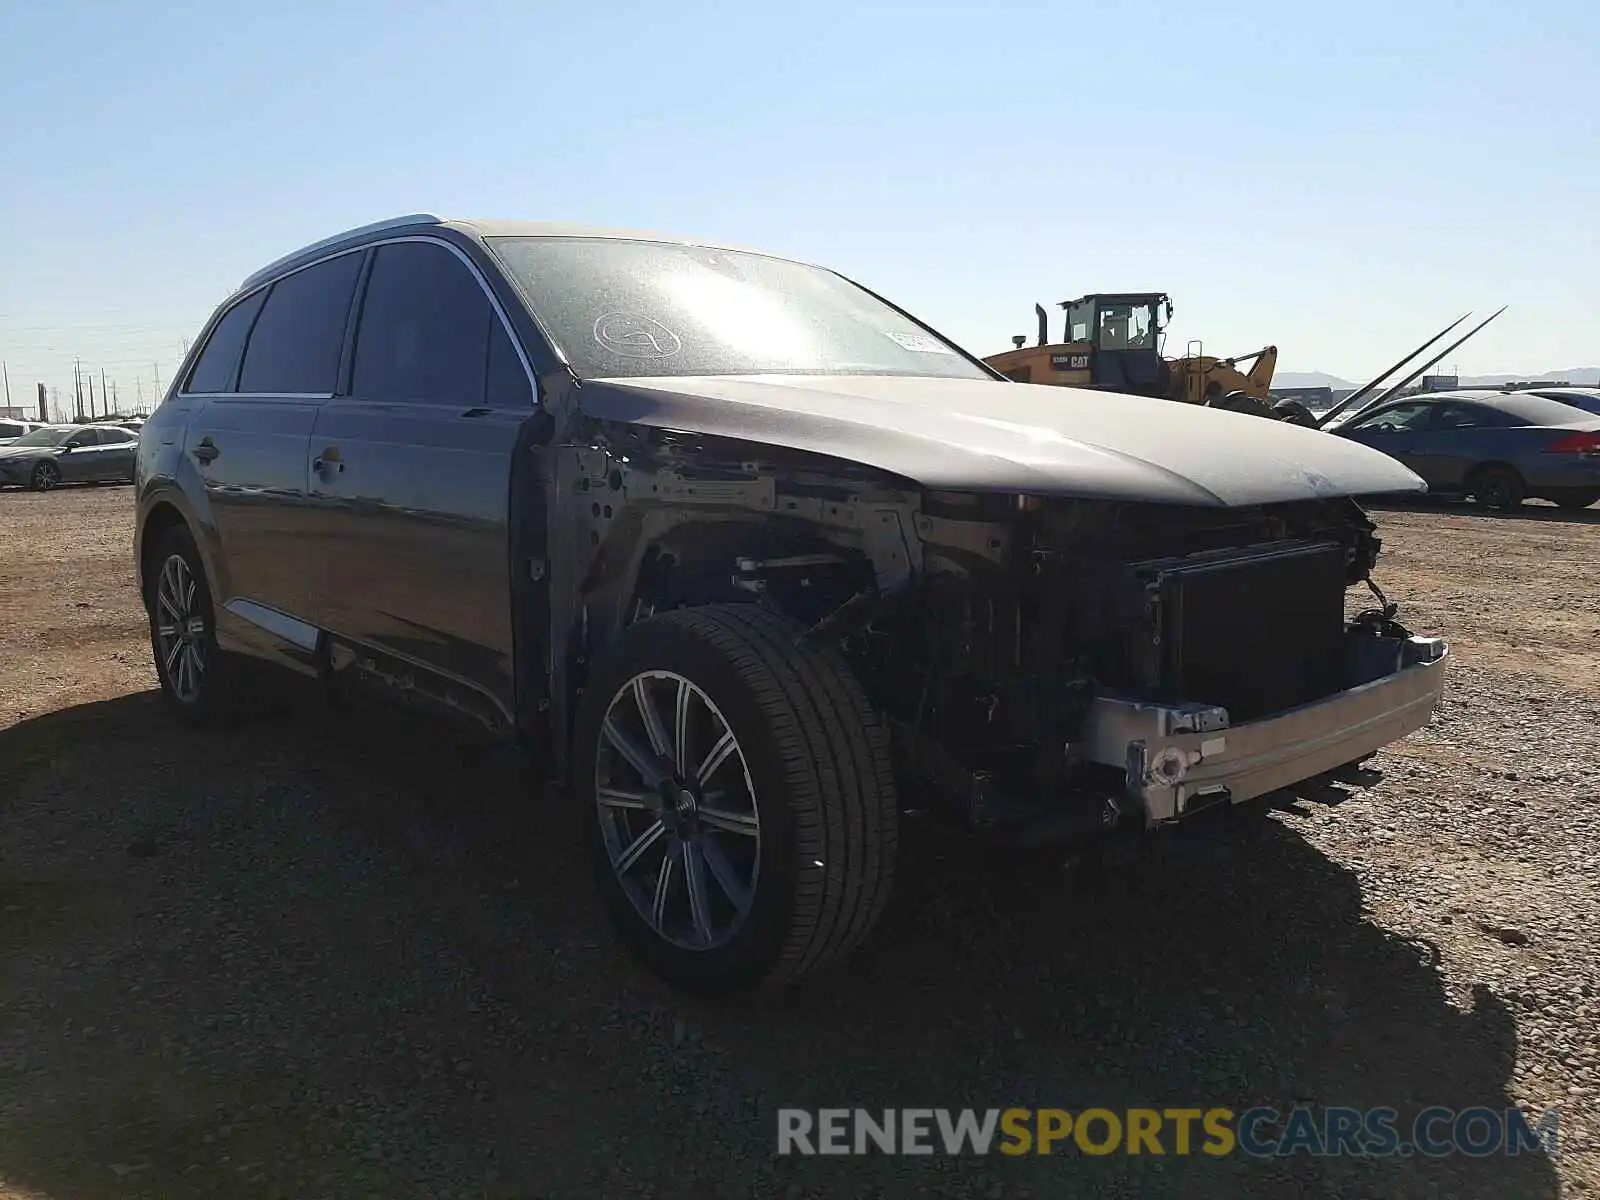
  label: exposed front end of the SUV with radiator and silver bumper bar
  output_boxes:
[851,493,1448,842]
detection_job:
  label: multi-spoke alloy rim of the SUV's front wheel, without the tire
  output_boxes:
[595,670,762,950]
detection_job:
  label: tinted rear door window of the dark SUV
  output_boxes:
[238,251,362,395]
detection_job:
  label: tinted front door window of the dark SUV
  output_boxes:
[350,242,494,405]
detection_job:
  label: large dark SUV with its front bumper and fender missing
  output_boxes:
[136,216,1446,994]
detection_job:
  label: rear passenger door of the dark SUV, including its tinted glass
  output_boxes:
[184,250,365,661]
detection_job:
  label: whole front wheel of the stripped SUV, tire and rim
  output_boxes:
[573,605,899,997]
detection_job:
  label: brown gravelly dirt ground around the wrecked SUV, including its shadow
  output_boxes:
[0,488,1600,1198]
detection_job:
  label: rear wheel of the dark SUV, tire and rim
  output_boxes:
[144,525,237,728]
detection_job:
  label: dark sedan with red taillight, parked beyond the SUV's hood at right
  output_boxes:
[1330,392,1600,509]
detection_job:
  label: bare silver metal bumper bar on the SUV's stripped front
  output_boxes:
[1072,634,1450,827]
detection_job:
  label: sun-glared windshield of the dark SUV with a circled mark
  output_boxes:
[488,237,994,379]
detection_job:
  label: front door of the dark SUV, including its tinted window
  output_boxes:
[309,238,534,717]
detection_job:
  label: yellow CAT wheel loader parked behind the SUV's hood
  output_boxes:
[984,291,1278,416]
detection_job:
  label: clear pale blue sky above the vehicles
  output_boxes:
[0,0,1600,412]
